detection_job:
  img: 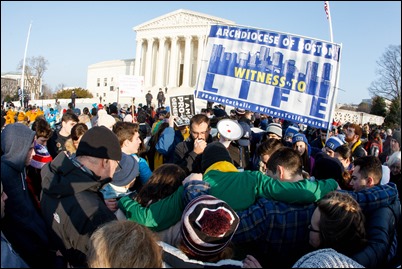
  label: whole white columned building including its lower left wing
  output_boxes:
[87,9,234,102]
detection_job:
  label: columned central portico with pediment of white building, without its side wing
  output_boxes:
[134,9,234,88]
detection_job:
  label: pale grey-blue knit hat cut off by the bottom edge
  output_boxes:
[292,248,364,268]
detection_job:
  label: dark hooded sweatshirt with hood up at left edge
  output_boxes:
[1,123,50,267]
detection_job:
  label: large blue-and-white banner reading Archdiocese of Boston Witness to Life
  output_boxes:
[195,25,341,128]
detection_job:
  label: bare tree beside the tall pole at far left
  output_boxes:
[18,56,49,99]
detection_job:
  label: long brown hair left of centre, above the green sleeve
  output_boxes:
[136,163,187,207]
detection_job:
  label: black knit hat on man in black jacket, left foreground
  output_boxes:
[76,126,121,161]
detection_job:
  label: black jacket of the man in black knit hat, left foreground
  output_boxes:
[40,153,116,267]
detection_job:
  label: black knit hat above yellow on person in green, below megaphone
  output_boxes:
[201,141,233,172]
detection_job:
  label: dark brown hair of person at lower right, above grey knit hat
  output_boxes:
[317,191,367,255]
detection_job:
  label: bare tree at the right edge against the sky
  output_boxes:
[368,45,401,101]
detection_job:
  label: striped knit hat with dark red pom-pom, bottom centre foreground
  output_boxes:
[181,195,239,257]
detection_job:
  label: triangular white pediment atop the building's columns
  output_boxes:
[134,9,234,31]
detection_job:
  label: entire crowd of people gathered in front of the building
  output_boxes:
[1,99,402,268]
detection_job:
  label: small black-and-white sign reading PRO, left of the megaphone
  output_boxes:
[169,94,195,126]
